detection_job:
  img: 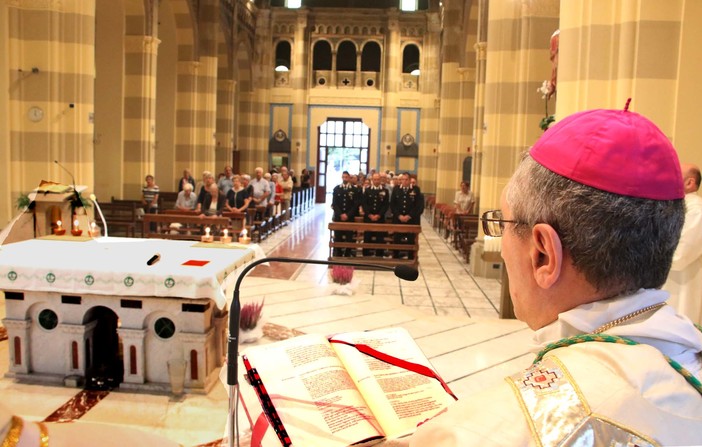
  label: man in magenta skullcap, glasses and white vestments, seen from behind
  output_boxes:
[409,110,702,447]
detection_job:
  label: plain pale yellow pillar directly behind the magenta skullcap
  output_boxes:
[558,0,702,171]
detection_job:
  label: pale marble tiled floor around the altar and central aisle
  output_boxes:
[0,205,533,446]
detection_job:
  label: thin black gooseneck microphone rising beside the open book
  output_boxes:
[227,257,419,447]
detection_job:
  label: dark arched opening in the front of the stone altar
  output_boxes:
[83,306,124,389]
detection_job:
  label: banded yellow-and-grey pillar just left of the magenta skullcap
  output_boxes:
[479,0,559,215]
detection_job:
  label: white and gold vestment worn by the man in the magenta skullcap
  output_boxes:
[410,290,702,447]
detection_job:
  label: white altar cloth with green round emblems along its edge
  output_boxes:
[0,236,262,308]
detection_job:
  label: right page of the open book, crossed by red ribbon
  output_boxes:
[331,328,454,438]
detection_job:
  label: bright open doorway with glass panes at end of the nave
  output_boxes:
[317,118,370,203]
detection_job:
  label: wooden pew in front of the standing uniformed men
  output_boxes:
[328,222,422,267]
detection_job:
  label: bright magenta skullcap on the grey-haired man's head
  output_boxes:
[529,102,685,200]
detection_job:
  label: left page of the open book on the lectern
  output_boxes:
[244,334,382,447]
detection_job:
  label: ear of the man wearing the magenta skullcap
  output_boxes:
[530,224,563,289]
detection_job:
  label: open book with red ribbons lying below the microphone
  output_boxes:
[239,328,455,447]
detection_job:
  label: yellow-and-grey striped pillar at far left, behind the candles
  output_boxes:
[0,0,95,226]
